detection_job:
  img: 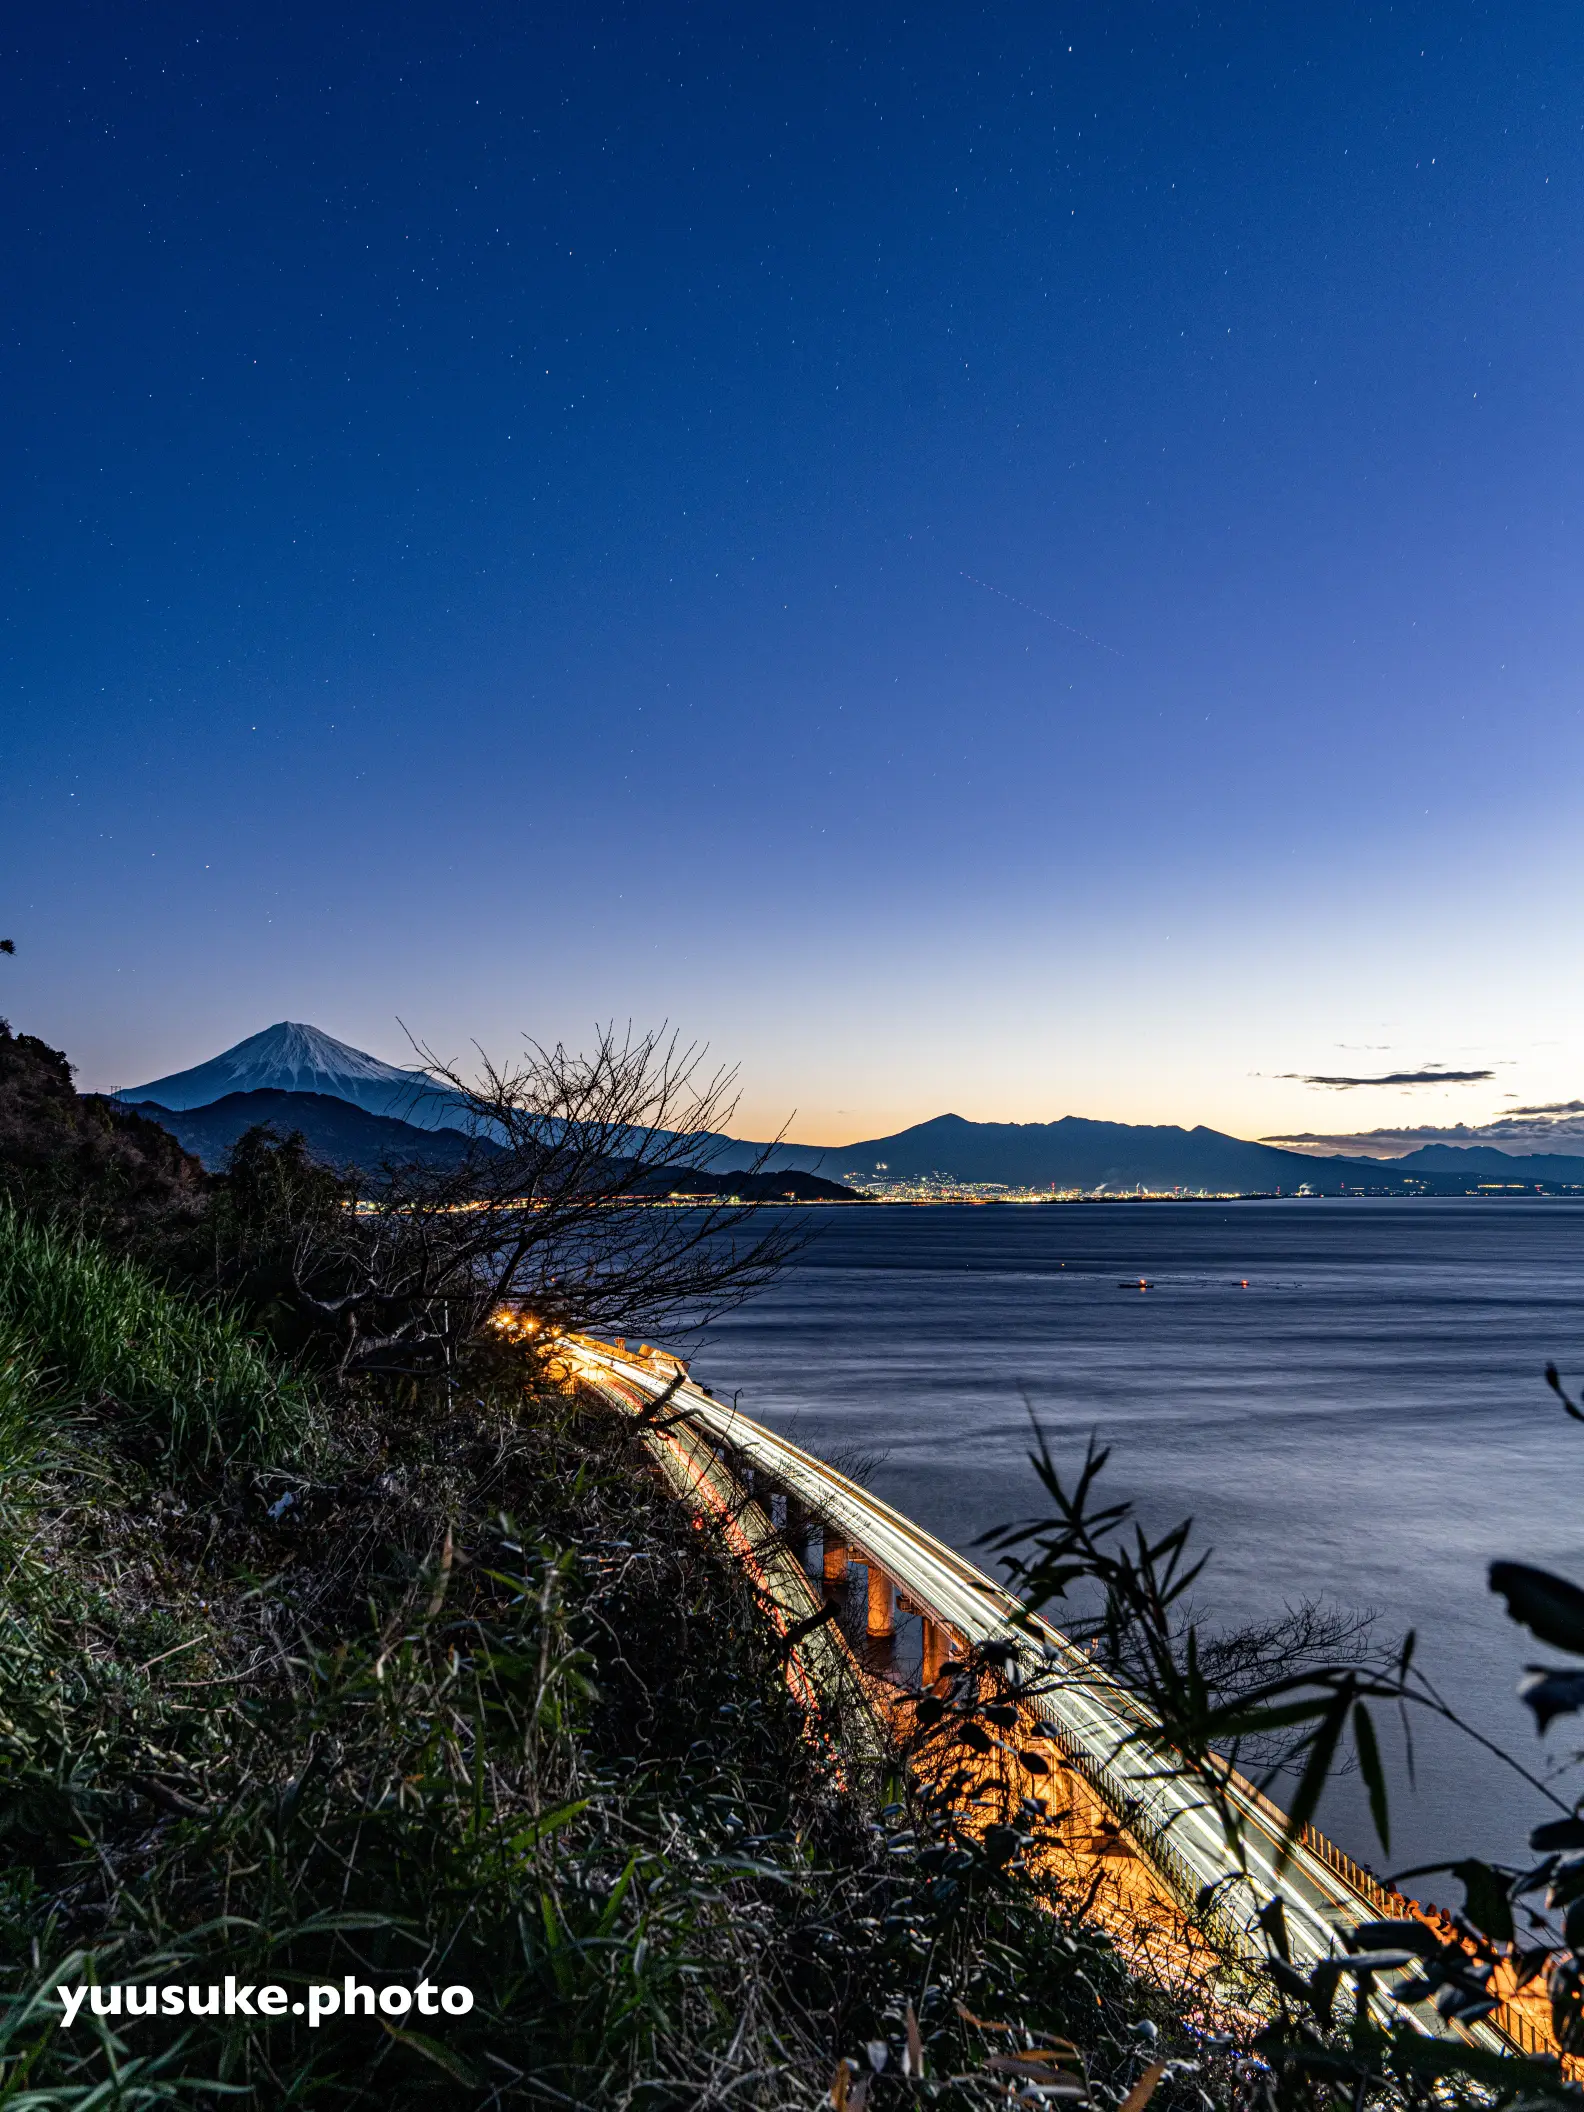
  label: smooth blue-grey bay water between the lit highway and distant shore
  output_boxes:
[693,1198,1584,1875]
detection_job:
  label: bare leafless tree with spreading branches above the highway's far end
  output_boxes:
[274,1026,803,1375]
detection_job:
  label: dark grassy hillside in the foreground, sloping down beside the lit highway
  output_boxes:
[0,1214,1198,2108]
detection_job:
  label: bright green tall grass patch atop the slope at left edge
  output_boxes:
[0,1204,313,1466]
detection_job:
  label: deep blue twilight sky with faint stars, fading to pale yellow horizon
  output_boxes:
[0,0,1584,1140]
